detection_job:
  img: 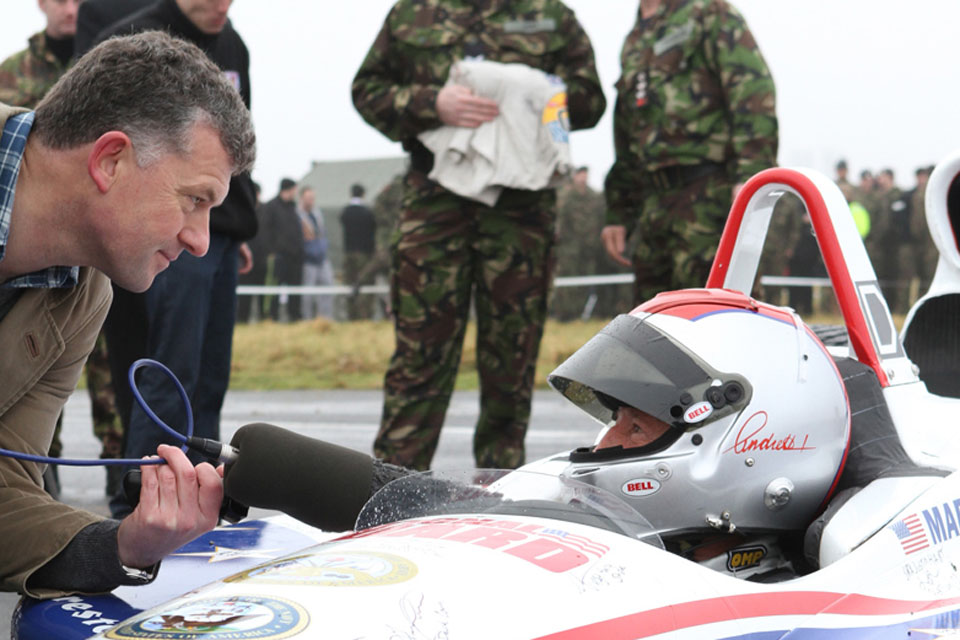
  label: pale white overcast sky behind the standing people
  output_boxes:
[0,0,960,198]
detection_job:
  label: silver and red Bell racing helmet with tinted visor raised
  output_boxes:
[548,289,850,535]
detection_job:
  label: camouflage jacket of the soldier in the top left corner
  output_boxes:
[0,31,67,109]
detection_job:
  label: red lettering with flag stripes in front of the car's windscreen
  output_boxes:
[350,517,610,573]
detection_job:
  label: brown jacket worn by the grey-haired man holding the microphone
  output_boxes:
[0,106,111,597]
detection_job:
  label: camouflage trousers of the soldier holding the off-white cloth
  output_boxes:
[374,172,556,469]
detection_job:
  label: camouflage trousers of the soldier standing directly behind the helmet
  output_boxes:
[633,173,733,304]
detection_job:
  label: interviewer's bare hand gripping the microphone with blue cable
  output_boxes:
[117,444,223,569]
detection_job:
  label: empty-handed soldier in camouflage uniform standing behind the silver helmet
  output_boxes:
[603,0,777,302]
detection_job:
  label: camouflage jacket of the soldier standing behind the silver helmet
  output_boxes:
[606,0,777,224]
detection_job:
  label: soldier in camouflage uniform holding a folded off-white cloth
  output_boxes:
[353,0,606,469]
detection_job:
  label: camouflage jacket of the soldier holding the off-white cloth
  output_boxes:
[353,0,606,150]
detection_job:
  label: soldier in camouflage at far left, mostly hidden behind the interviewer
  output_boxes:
[0,0,123,496]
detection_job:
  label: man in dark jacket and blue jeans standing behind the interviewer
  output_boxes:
[96,0,257,516]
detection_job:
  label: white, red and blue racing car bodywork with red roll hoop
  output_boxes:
[14,156,960,640]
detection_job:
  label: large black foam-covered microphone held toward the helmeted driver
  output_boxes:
[223,423,374,531]
